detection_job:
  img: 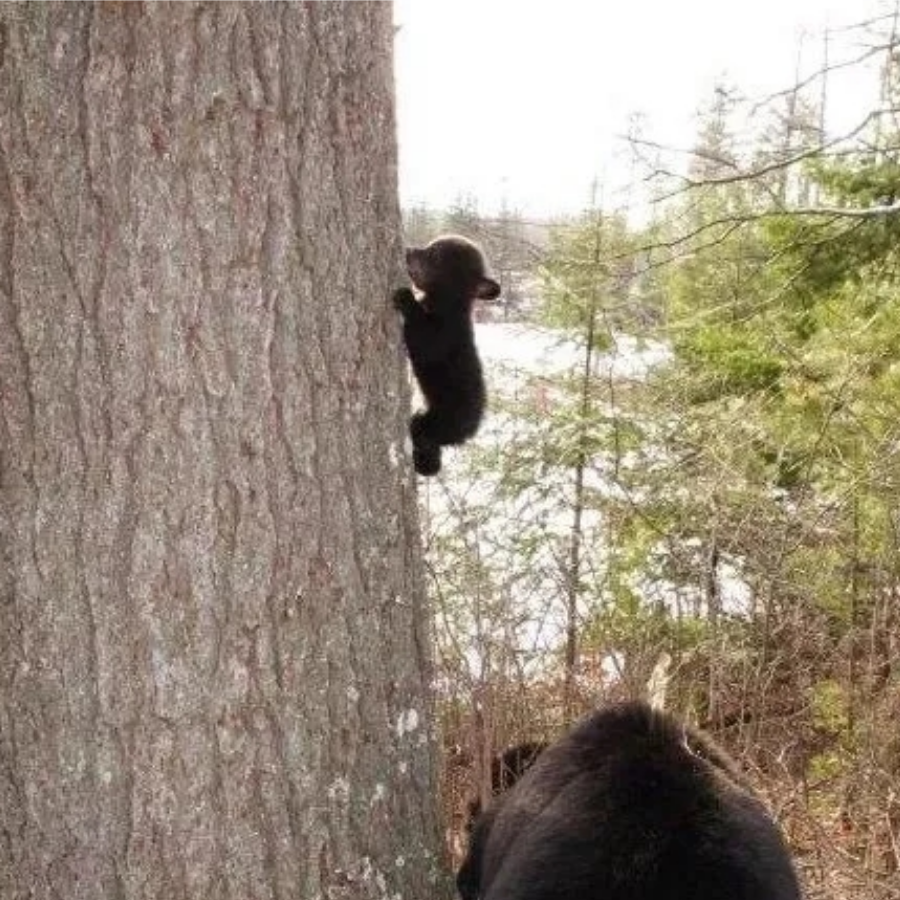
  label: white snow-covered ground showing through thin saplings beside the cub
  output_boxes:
[420,322,750,677]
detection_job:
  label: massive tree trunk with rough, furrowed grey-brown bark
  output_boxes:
[0,0,438,900]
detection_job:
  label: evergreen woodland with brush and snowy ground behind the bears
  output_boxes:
[405,13,900,898]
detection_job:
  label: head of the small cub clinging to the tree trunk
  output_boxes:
[406,235,500,300]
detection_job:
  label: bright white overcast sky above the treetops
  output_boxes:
[395,0,886,216]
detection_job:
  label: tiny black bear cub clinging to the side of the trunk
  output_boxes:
[394,235,500,475]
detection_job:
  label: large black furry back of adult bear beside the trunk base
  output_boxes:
[457,703,800,900]
